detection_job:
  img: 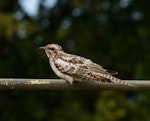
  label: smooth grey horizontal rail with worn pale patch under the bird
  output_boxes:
[0,78,150,91]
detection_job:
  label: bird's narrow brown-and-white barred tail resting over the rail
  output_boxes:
[100,74,135,87]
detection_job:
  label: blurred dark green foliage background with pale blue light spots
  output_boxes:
[0,0,150,121]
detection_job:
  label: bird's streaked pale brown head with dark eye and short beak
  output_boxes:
[39,44,63,58]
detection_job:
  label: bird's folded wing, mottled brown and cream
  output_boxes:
[55,54,116,82]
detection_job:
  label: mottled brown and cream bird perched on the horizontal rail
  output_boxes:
[39,44,133,86]
